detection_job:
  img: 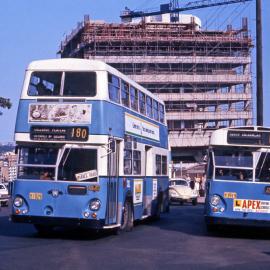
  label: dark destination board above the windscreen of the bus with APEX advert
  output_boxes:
[227,130,270,146]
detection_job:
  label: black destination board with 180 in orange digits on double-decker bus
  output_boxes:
[30,126,89,142]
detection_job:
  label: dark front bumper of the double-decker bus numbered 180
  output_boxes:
[11,215,105,229]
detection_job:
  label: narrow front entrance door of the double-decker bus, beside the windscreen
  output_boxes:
[106,139,120,225]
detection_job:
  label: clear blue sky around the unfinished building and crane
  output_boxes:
[0,0,270,142]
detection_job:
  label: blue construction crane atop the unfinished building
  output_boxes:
[120,0,252,22]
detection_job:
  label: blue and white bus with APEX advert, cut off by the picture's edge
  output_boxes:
[205,126,270,230]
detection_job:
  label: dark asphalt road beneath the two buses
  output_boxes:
[0,205,270,270]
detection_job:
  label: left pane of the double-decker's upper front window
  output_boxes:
[28,72,62,96]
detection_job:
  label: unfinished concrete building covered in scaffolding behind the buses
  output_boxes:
[60,14,253,162]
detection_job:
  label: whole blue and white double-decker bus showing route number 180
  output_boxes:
[12,59,169,232]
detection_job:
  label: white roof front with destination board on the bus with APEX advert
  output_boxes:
[210,126,270,147]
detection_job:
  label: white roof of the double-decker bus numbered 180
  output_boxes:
[27,58,164,105]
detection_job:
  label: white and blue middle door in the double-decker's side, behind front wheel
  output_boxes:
[143,145,154,216]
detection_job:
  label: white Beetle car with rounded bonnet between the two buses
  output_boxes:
[169,178,199,205]
